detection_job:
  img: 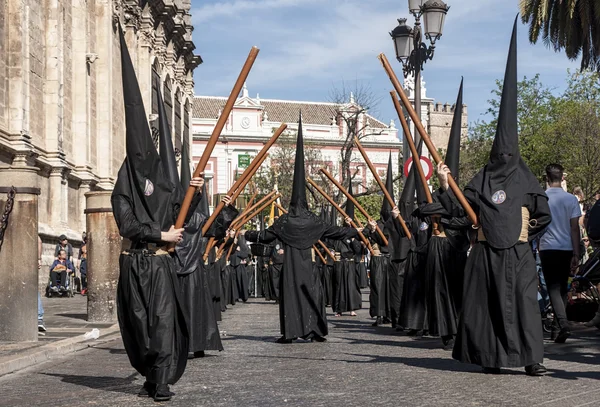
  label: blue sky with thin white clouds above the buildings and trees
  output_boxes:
[192,0,578,126]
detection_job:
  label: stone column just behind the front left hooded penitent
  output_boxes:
[85,191,121,322]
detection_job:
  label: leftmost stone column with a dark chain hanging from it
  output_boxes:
[0,165,40,341]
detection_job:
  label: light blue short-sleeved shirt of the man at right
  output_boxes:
[540,187,581,250]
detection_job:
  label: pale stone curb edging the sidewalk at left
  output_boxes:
[0,324,120,377]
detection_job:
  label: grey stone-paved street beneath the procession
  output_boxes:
[0,296,600,407]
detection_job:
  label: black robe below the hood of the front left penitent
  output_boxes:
[112,195,189,384]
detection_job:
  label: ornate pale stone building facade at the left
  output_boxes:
[0,0,202,284]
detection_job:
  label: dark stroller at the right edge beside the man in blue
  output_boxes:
[567,249,600,322]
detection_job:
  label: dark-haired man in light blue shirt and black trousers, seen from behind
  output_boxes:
[540,164,581,343]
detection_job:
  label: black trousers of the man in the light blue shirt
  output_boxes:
[540,250,573,328]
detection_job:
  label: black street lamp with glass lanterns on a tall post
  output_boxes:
[390,0,450,166]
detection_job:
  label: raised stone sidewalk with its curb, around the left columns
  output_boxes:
[0,294,119,376]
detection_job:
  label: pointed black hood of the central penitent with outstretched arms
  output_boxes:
[272,113,326,249]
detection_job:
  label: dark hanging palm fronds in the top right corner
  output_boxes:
[519,0,600,72]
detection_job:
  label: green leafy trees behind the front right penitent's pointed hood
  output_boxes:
[460,72,600,204]
